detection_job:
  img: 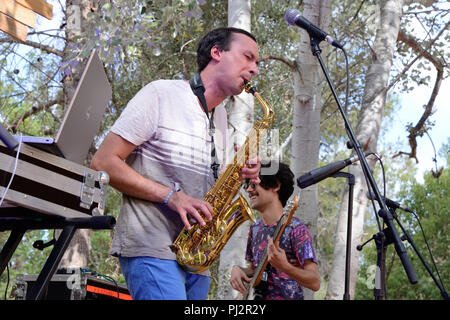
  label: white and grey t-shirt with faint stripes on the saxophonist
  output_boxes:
[110,80,227,268]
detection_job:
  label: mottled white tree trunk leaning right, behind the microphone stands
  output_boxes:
[326,0,402,300]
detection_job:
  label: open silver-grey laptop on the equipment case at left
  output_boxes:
[15,50,112,165]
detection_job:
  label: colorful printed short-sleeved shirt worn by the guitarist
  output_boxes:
[245,217,317,300]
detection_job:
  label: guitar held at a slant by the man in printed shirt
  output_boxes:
[242,196,299,300]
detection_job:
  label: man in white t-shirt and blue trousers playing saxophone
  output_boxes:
[91,28,260,300]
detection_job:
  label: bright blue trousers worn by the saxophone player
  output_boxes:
[119,257,210,300]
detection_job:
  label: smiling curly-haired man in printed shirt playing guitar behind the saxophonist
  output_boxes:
[230,162,320,300]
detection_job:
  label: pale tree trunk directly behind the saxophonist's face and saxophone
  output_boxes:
[218,0,254,299]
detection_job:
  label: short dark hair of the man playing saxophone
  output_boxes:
[197,27,256,73]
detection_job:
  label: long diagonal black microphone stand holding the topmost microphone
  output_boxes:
[310,36,417,296]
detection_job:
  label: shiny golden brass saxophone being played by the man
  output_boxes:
[171,82,274,273]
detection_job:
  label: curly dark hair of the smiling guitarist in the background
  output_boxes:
[245,161,294,207]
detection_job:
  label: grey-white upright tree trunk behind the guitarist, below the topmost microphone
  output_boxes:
[291,0,331,300]
